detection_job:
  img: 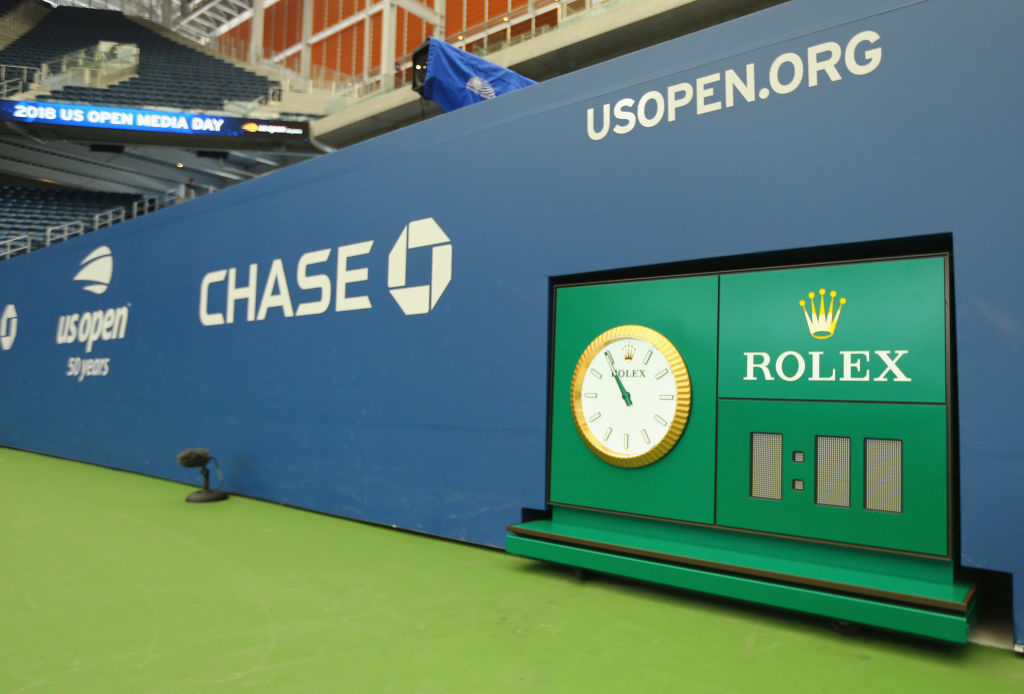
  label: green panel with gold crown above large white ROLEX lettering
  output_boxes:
[719,257,946,402]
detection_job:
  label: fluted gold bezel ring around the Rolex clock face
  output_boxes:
[570,326,691,468]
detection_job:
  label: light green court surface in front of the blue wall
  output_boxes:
[0,448,1024,694]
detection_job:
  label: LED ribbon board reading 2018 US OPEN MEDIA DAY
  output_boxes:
[0,101,308,140]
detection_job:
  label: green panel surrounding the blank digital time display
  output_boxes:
[717,399,948,556]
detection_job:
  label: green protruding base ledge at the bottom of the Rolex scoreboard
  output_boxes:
[506,508,977,643]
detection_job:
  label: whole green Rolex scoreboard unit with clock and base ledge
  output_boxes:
[507,255,974,642]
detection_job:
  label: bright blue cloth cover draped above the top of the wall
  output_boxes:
[423,38,537,112]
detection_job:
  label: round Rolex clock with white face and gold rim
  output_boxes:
[571,326,690,468]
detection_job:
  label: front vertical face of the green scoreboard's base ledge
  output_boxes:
[506,536,969,643]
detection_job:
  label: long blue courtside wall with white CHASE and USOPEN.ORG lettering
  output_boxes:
[0,0,1024,642]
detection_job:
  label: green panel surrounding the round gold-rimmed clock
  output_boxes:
[551,276,718,523]
